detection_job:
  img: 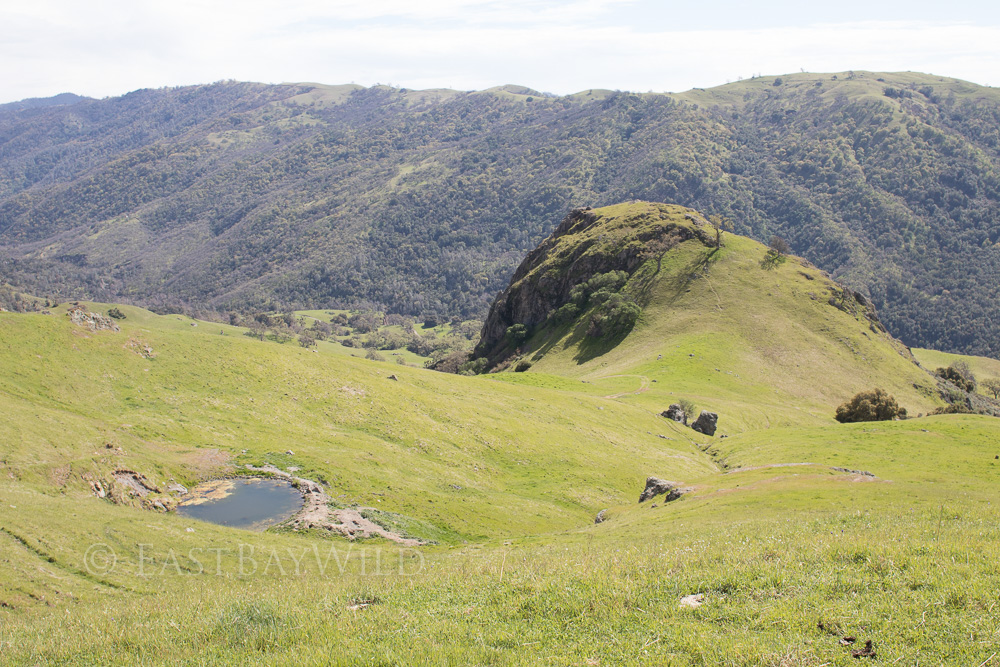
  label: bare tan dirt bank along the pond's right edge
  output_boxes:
[246,465,425,547]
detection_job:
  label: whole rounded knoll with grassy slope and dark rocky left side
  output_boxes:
[471,202,972,433]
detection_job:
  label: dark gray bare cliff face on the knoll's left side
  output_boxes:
[474,207,709,365]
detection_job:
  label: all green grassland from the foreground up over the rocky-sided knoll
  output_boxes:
[0,202,1000,665]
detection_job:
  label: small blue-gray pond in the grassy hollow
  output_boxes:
[177,478,302,530]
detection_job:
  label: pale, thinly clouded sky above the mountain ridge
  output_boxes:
[0,0,1000,103]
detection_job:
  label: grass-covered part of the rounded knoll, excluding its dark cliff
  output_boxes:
[484,203,942,434]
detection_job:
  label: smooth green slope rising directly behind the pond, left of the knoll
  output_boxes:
[0,305,711,537]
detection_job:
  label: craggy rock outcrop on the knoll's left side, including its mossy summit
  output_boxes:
[473,204,714,366]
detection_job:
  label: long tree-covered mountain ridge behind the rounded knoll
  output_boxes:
[0,72,1000,355]
